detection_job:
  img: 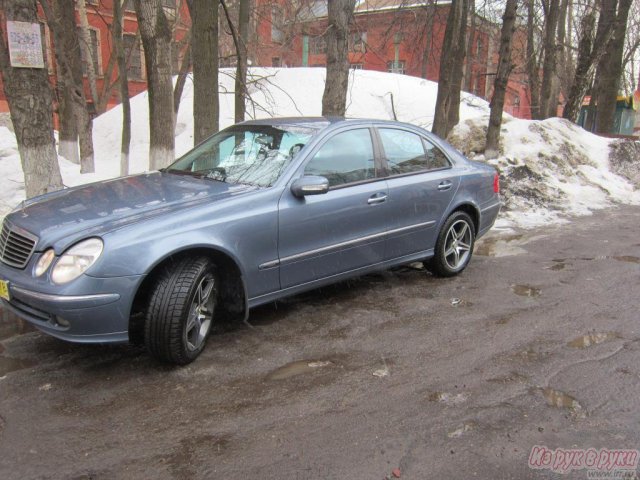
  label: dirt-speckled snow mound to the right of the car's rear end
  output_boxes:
[449,115,640,227]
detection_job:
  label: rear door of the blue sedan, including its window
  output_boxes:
[377,127,460,259]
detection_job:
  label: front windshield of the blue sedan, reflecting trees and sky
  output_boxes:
[166,124,324,187]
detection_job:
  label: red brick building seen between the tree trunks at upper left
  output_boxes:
[0,0,191,112]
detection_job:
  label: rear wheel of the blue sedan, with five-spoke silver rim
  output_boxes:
[424,211,476,277]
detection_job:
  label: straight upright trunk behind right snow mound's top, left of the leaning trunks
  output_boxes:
[540,0,560,119]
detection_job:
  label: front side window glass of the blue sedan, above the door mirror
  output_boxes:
[304,128,376,187]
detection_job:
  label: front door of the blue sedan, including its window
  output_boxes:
[278,126,388,289]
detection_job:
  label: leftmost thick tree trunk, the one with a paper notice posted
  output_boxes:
[0,0,62,198]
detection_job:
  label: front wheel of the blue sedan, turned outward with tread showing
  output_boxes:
[145,257,218,365]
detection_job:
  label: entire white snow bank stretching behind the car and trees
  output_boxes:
[0,68,640,231]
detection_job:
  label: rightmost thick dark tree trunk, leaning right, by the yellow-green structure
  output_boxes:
[596,0,632,133]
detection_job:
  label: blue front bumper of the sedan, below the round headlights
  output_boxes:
[0,265,142,343]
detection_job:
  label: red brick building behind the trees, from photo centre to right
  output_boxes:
[252,0,531,118]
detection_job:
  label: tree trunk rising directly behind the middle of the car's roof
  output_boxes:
[322,0,356,117]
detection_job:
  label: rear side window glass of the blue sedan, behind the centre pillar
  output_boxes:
[378,128,449,175]
